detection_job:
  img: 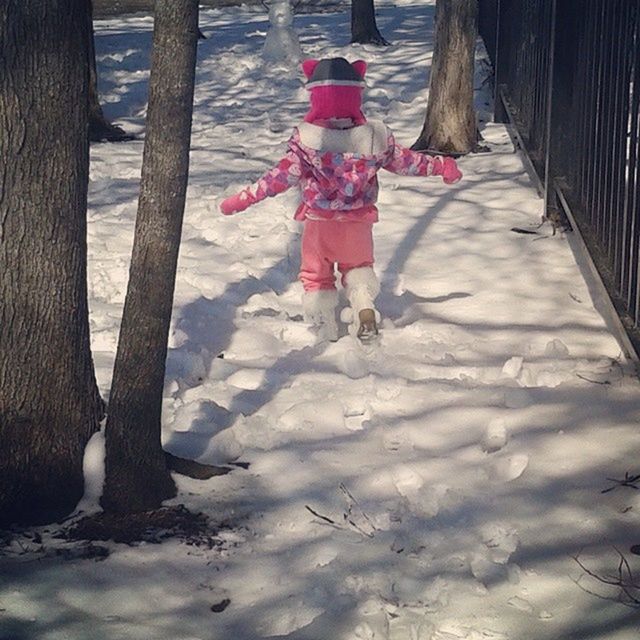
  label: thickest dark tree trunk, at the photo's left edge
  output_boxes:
[0,0,103,525]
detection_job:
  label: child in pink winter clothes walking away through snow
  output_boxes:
[220,58,462,342]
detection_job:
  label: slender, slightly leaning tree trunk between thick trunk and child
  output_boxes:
[102,0,198,513]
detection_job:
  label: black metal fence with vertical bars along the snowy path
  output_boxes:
[479,0,640,347]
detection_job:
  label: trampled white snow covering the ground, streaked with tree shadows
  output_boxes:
[0,0,640,640]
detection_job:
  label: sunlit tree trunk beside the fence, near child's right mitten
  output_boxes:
[412,0,479,154]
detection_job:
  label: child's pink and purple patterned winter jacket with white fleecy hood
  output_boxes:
[249,121,439,222]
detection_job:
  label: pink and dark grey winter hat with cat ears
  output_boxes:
[302,58,367,125]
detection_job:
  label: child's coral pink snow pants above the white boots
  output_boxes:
[300,220,373,291]
